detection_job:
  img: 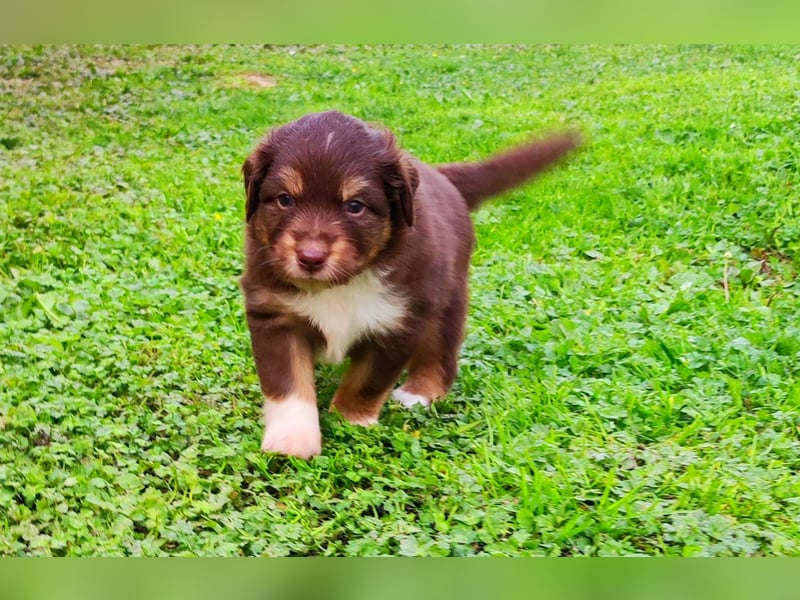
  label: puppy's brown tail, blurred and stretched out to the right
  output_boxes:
[436,133,581,210]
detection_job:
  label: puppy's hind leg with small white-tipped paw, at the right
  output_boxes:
[392,287,467,408]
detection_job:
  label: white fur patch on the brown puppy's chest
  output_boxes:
[283,272,406,363]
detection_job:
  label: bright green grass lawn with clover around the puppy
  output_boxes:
[0,46,800,556]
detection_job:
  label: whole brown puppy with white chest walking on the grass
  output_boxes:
[242,112,578,458]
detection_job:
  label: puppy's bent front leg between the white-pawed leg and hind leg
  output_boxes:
[331,344,408,425]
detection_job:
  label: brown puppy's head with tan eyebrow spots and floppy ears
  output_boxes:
[242,112,418,290]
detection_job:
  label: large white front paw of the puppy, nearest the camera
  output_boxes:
[261,396,322,459]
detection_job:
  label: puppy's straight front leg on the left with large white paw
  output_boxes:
[247,312,322,458]
